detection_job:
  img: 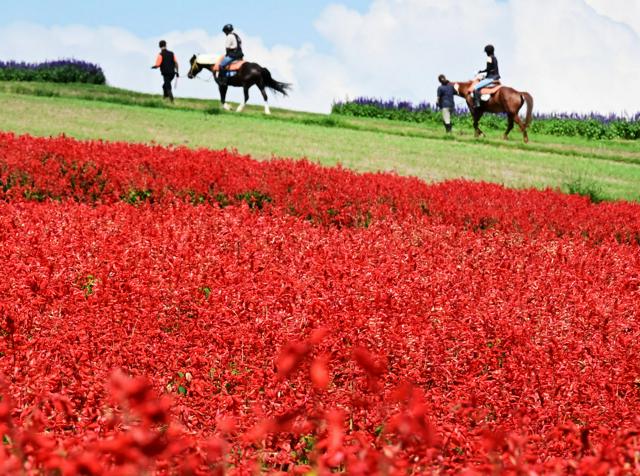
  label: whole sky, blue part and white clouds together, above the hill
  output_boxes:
[0,0,640,114]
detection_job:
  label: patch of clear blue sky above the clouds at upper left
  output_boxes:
[0,0,371,51]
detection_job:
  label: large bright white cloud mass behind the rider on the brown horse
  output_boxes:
[316,0,640,113]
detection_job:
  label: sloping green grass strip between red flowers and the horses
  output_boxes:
[0,82,640,200]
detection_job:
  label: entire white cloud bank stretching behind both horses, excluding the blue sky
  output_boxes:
[0,0,640,113]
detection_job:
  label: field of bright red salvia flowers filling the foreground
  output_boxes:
[0,134,640,475]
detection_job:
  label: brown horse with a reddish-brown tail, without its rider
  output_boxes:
[453,80,533,142]
